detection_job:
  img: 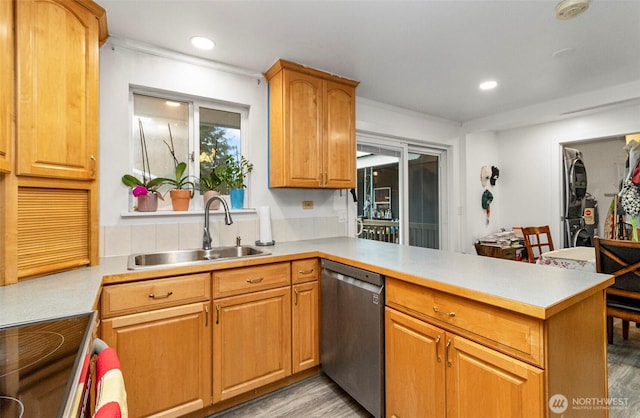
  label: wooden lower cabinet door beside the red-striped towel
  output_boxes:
[102,302,211,417]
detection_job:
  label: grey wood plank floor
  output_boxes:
[209,320,640,418]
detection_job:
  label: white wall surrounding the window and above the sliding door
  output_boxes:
[100,38,460,256]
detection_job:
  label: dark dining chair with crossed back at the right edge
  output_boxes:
[593,238,640,344]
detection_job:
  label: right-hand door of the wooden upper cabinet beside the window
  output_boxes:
[322,81,356,189]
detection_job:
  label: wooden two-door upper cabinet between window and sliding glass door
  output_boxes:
[265,60,358,189]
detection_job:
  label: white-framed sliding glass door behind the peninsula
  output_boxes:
[357,136,446,249]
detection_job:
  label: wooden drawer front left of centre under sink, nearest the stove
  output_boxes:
[102,273,211,318]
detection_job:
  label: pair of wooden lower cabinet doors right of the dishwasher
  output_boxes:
[385,308,544,418]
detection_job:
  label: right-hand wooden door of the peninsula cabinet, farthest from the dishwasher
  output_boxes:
[446,333,545,418]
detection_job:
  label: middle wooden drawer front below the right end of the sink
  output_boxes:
[213,263,291,299]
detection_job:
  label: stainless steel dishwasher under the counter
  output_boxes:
[320,259,384,418]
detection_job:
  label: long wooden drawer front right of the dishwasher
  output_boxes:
[386,278,543,366]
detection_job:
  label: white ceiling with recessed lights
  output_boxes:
[97,0,640,122]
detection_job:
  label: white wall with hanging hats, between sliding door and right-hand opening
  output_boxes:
[463,104,640,253]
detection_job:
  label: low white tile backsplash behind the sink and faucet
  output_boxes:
[100,216,347,257]
